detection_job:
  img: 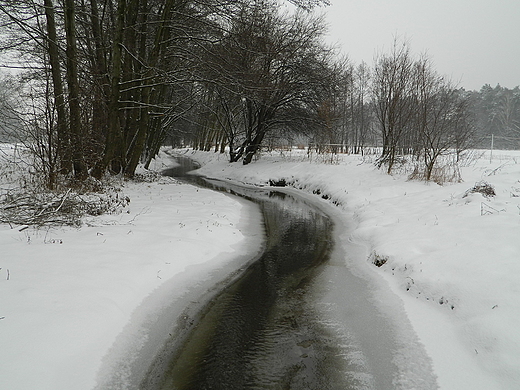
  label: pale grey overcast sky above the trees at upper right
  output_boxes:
[325,0,520,90]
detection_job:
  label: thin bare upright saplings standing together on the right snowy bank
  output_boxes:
[372,42,474,180]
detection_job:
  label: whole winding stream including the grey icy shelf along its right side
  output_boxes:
[96,158,438,390]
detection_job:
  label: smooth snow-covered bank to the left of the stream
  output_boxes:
[0,152,262,390]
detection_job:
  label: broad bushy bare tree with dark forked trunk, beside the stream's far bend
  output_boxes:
[201,1,331,164]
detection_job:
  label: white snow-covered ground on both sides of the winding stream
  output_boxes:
[0,145,520,390]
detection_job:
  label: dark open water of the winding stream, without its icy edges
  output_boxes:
[141,156,357,390]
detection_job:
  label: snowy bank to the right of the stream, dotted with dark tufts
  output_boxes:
[186,147,520,390]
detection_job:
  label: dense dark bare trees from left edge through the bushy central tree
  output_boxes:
[0,0,326,187]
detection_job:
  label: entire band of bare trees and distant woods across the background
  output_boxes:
[0,0,520,189]
